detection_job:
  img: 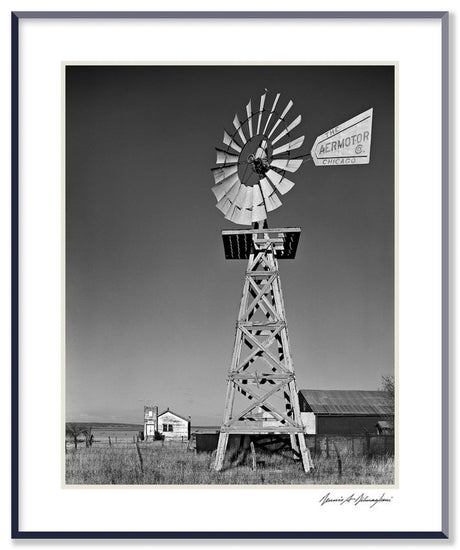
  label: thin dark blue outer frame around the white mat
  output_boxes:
[11,11,449,539]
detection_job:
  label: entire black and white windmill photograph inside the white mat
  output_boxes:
[62,63,398,487]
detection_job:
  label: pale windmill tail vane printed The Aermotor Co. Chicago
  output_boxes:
[311,109,373,166]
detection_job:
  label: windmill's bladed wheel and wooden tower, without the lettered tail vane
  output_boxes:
[212,90,313,472]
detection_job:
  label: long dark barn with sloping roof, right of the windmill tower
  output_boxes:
[299,390,394,435]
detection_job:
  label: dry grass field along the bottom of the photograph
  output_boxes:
[65,440,394,485]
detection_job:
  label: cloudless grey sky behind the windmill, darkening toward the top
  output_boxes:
[65,65,395,425]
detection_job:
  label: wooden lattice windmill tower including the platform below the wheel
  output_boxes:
[215,228,312,472]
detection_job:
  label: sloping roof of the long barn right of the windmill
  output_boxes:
[299,390,394,416]
